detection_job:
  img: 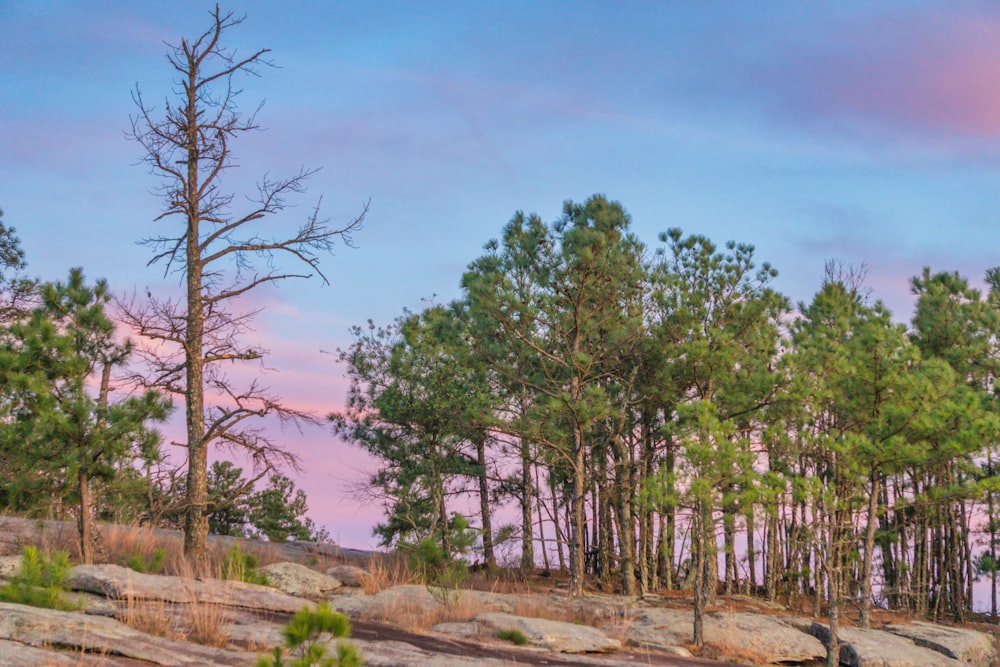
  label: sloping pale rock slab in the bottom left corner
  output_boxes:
[0,602,257,667]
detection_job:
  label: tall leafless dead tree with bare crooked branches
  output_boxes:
[123,6,367,565]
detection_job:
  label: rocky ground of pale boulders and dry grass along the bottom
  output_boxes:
[0,517,998,667]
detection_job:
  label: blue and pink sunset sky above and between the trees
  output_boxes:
[0,0,1000,548]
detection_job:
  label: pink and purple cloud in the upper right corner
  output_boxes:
[733,7,1000,149]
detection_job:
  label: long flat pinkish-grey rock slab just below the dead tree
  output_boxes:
[66,565,306,613]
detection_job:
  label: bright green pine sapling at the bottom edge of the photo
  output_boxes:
[257,602,364,667]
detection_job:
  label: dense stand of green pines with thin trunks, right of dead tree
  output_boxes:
[331,196,1000,633]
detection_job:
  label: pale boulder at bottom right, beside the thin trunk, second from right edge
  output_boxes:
[809,623,963,667]
